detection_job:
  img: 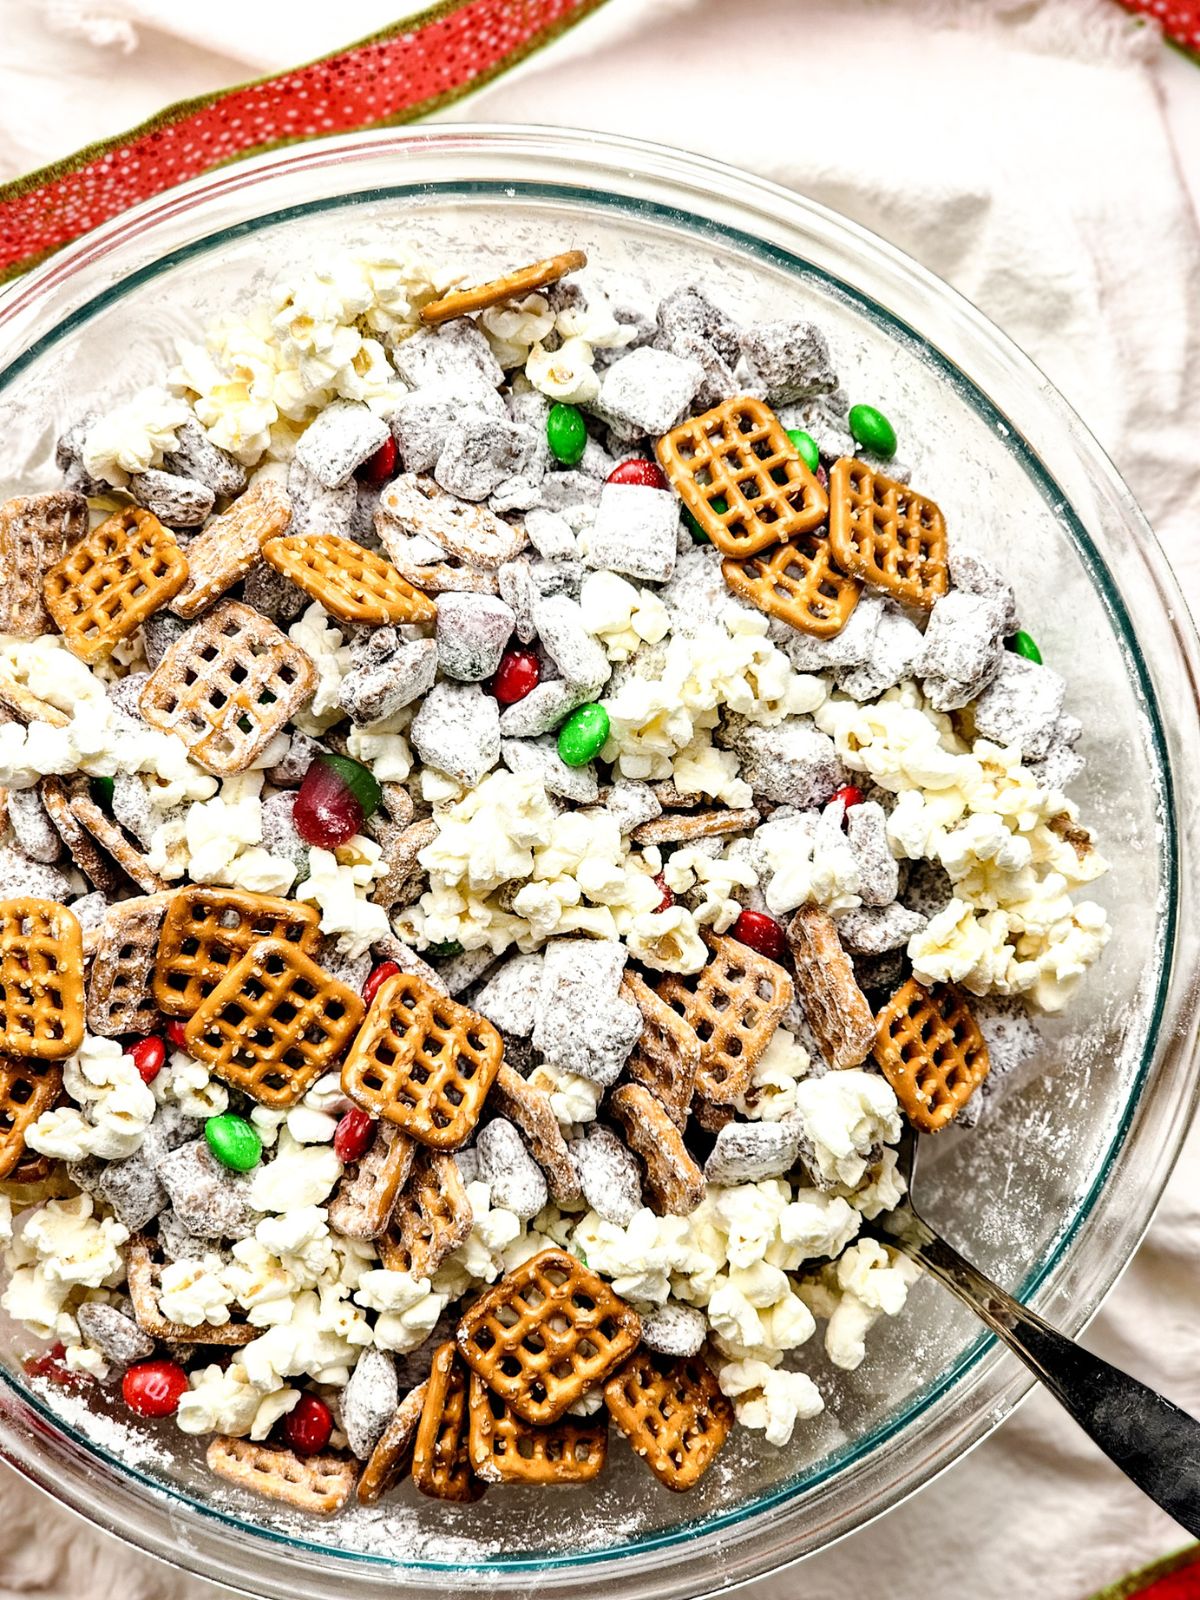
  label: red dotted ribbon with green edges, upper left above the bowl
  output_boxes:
[0,0,603,283]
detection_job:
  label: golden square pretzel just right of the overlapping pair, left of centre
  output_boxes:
[342,973,504,1150]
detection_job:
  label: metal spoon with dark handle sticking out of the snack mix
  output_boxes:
[864,1128,1200,1538]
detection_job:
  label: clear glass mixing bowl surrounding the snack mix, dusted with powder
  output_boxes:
[0,126,1200,1600]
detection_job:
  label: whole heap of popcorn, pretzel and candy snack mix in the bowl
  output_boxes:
[0,236,1109,1515]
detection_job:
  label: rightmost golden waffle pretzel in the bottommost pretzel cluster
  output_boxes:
[605,1350,733,1491]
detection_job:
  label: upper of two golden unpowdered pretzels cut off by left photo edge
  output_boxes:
[0,896,83,1061]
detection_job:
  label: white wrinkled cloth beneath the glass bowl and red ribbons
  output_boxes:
[0,0,1200,1600]
